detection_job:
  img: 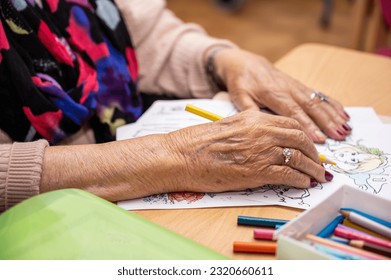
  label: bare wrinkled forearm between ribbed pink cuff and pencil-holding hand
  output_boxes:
[40,135,185,201]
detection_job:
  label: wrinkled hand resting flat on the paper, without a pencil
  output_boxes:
[214,49,351,143]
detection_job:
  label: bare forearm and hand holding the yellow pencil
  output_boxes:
[40,110,326,201]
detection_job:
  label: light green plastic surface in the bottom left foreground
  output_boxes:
[0,189,227,260]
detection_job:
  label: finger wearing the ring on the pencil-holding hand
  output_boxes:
[281,148,326,182]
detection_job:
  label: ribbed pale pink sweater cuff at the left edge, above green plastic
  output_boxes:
[0,140,48,213]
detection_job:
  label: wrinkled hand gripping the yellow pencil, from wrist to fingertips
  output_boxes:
[167,110,326,192]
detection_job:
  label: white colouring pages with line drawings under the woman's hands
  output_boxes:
[117,99,391,210]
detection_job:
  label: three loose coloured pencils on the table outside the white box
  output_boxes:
[233,216,288,254]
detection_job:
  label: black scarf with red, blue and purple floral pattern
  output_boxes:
[0,0,142,144]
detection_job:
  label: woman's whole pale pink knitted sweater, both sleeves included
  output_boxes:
[0,0,234,212]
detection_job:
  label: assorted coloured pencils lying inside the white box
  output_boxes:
[303,208,391,260]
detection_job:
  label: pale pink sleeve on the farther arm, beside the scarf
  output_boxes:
[115,0,236,98]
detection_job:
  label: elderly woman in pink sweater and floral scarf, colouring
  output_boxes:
[0,0,350,211]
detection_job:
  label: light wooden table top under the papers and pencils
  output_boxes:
[134,44,391,259]
